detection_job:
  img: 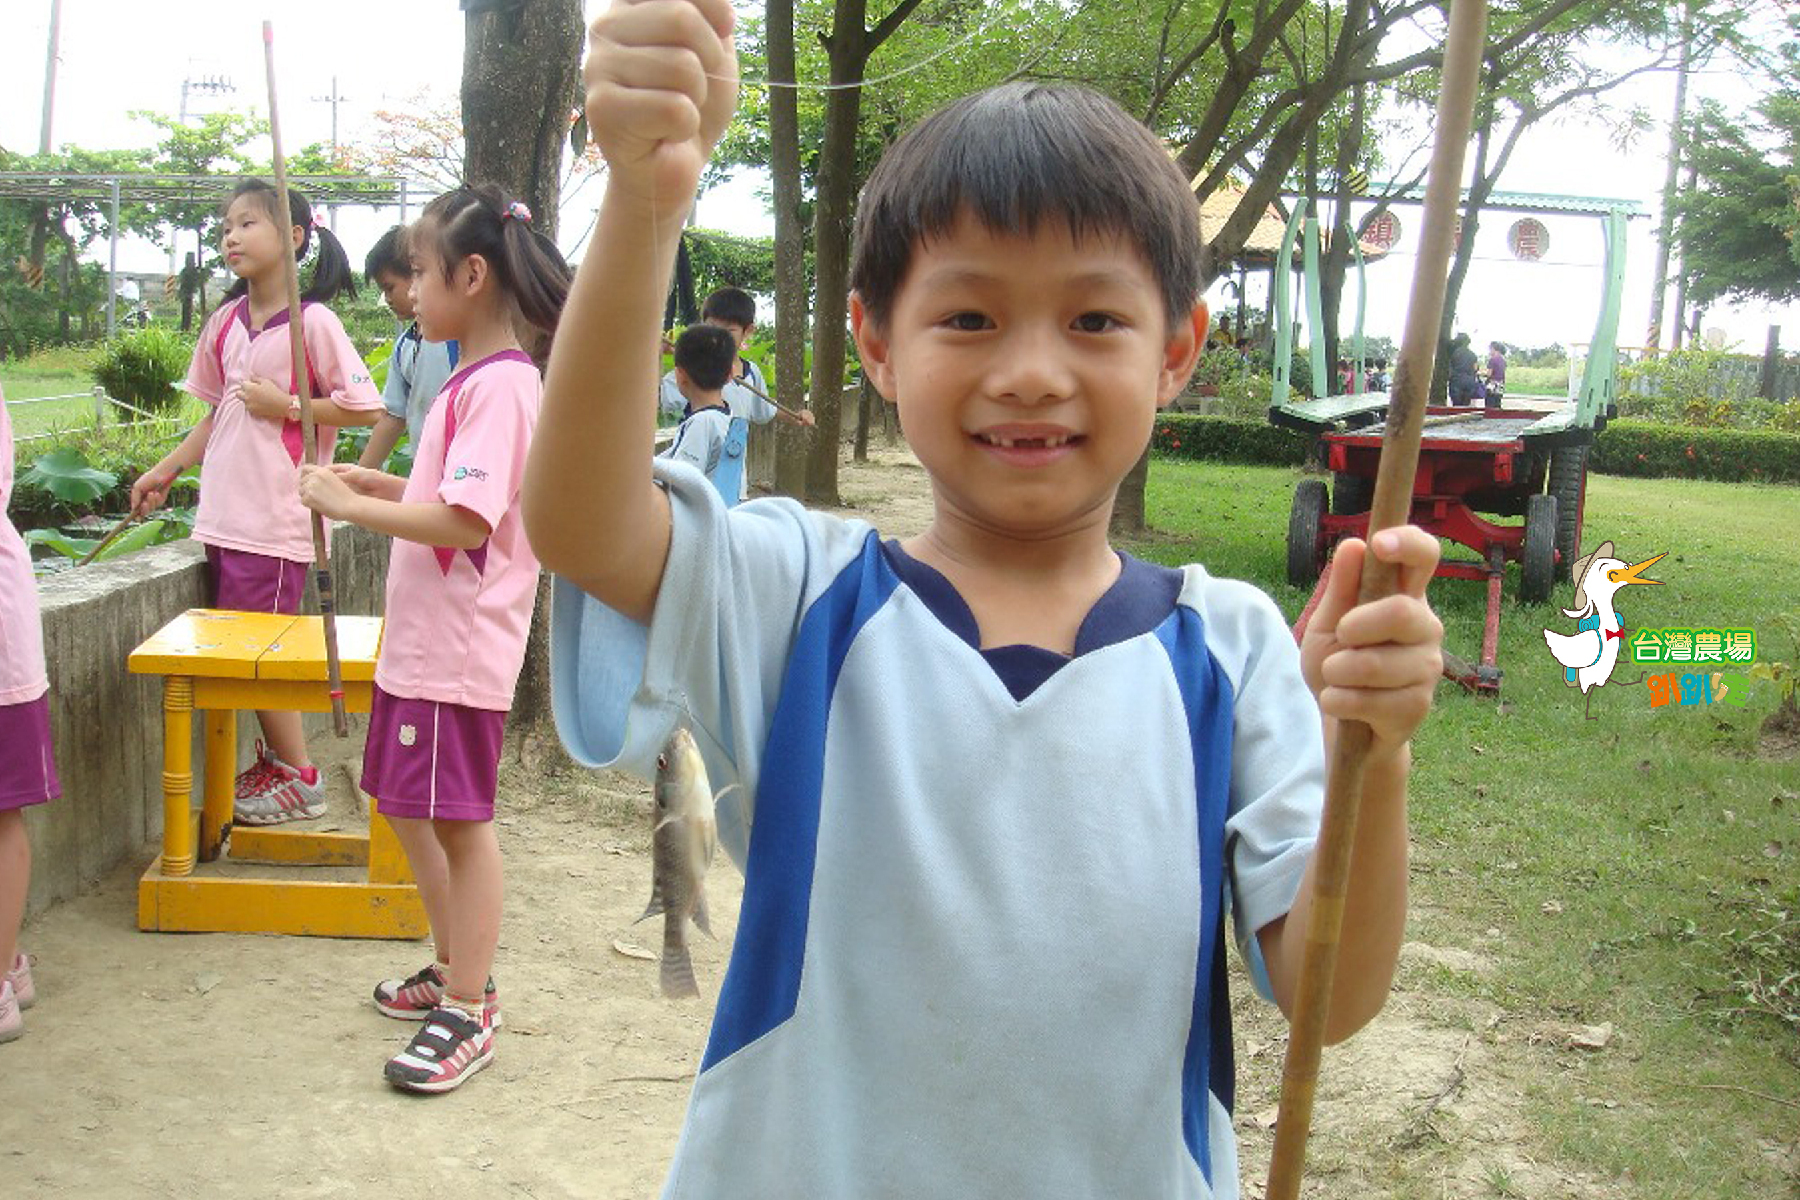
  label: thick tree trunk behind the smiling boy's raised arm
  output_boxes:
[463,0,579,763]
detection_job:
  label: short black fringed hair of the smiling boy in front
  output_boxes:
[850,83,1201,326]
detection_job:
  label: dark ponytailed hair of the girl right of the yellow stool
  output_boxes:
[409,184,569,341]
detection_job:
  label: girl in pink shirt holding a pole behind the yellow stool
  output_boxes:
[131,180,382,826]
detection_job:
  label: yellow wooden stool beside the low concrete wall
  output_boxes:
[130,608,427,937]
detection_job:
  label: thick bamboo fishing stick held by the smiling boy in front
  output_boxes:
[1265,0,1487,1200]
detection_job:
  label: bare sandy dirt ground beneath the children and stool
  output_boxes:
[0,453,1627,1200]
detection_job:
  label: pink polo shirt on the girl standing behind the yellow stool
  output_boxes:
[184,297,382,561]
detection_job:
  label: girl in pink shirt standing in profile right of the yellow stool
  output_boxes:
[301,187,569,1092]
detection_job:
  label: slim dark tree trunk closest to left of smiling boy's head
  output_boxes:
[806,0,868,506]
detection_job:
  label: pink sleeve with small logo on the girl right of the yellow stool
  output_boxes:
[437,369,538,533]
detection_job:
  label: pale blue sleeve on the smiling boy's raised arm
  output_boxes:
[551,459,873,864]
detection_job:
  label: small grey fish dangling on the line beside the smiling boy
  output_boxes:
[637,727,729,1000]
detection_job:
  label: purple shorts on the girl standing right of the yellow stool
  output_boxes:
[362,687,506,820]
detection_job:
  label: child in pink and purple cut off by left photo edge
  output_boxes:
[0,392,61,1042]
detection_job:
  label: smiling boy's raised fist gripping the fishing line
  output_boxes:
[581,0,738,214]
